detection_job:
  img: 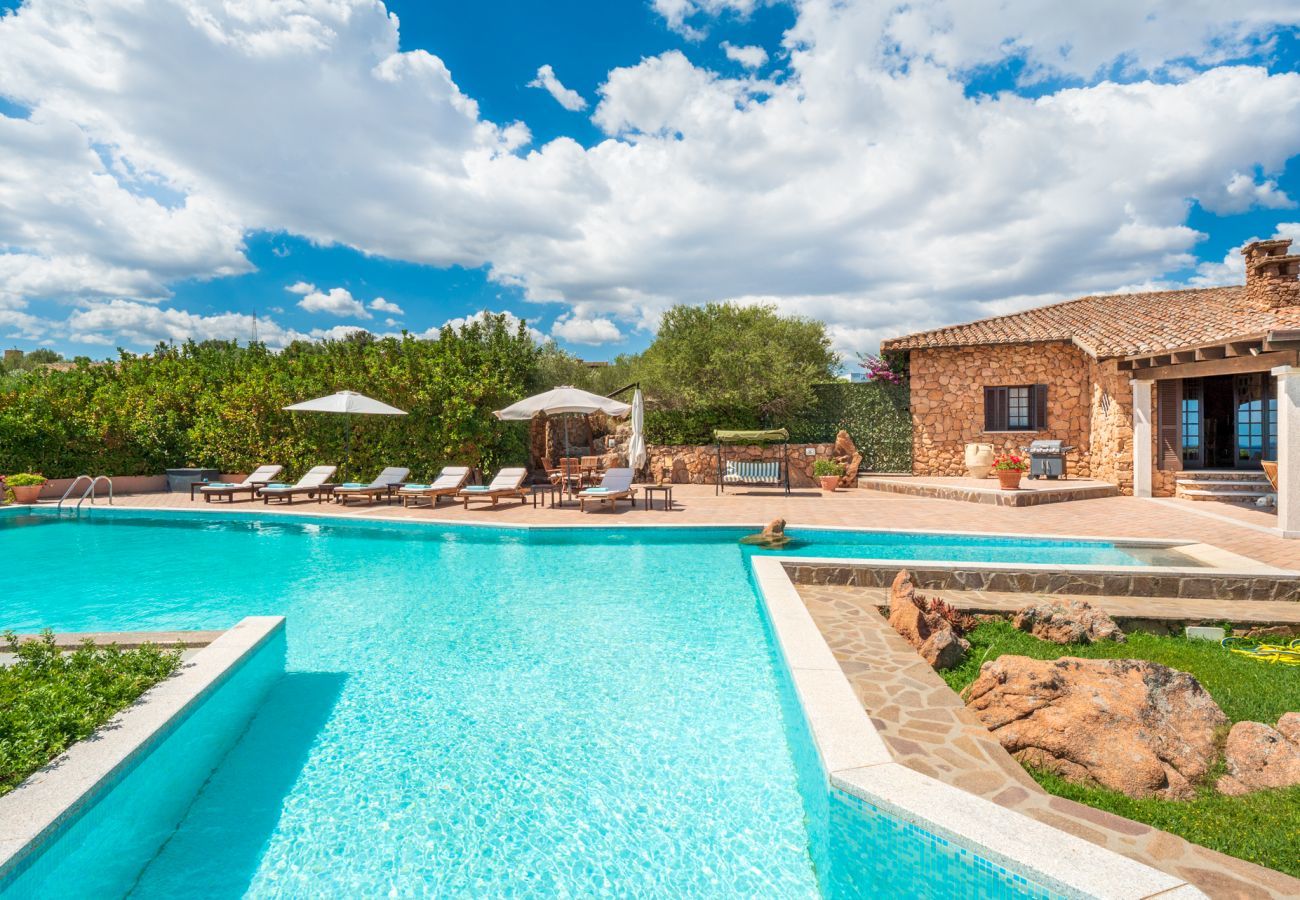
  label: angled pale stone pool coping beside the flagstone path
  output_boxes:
[753,557,1205,900]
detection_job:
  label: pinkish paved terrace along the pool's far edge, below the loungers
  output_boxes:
[76,484,1300,568]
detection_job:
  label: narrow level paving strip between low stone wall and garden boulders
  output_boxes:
[824,584,1300,626]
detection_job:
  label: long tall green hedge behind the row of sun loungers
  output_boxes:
[0,317,538,479]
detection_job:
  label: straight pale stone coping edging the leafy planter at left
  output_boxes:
[0,615,285,892]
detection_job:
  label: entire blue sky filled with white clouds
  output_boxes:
[0,0,1300,359]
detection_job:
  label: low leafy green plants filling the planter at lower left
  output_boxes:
[0,633,181,795]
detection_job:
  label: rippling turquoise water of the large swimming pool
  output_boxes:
[0,512,1086,897]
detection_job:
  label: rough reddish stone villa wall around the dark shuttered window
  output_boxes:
[910,341,1093,477]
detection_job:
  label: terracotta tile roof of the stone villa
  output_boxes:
[880,286,1300,359]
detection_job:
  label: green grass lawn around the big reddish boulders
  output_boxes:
[940,620,1300,878]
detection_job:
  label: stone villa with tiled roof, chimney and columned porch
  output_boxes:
[881,241,1300,537]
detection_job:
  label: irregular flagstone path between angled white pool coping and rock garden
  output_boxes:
[797,584,1300,899]
